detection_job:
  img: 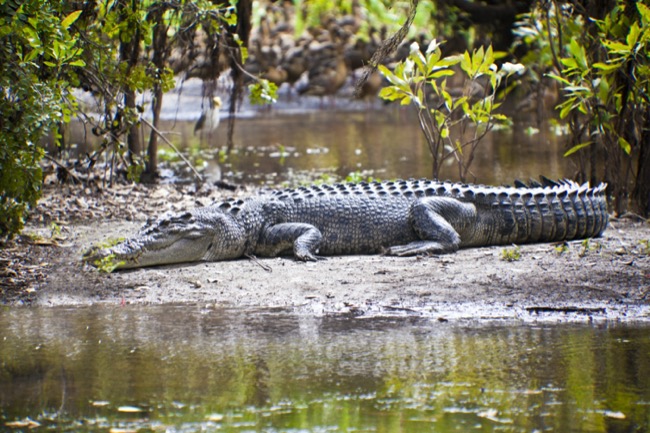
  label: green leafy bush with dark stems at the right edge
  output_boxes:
[518,0,650,214]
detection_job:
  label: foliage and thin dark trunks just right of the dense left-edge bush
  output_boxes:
[72,0,237,181]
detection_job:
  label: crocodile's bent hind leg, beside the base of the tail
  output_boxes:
[385,197,476,256]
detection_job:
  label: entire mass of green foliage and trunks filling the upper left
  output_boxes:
[0,0,246,239]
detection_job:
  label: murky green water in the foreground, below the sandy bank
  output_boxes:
[0,306,650,432]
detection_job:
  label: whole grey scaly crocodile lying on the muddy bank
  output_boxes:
[85,179,608,268]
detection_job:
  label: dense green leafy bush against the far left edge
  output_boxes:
[0,0,85,240]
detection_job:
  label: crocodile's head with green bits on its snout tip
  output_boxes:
[83,210,244,272]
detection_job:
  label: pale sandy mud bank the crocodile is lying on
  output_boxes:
[0,178,650,321]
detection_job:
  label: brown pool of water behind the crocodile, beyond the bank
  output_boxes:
[60,107,571,184]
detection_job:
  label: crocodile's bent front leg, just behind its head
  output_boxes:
[255,223,323,261]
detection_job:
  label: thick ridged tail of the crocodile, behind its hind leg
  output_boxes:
[465,179,608,244]
